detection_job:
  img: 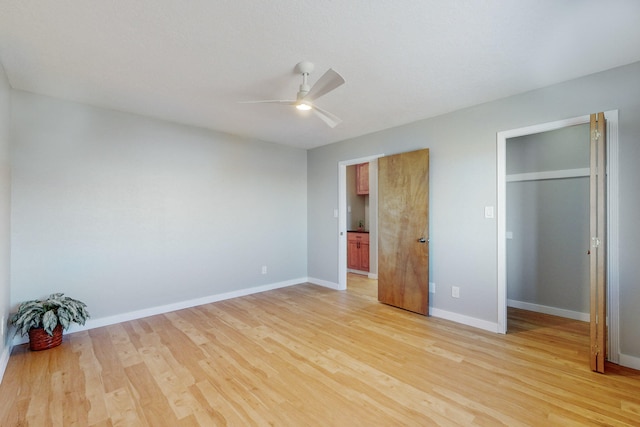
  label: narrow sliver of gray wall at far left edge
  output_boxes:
[0,64,11,372]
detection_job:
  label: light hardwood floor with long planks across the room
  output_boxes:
[0,284,640,427]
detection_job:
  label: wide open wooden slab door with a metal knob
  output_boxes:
[378,149,429,315]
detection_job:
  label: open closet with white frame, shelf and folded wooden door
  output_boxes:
[497,111,619,372]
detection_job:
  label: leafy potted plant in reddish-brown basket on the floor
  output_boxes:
[10,293,89,350]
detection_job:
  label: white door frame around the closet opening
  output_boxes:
[496,110,620,363]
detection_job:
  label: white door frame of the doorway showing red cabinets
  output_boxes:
[337,154,384,290]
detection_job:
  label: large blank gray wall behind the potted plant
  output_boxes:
[11,91,307,319]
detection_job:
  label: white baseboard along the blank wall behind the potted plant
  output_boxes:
[13,277,307,345]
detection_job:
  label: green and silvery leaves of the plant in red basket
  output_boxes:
[10,293,90,336]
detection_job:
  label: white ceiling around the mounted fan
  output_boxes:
[0,0,640,148]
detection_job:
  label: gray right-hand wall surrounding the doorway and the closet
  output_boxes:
[308,63,640,357]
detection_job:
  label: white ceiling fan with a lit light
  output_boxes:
[242,61,344,128]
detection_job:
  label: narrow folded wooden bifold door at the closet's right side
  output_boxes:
[589,113,607,373]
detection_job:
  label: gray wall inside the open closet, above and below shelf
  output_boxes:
[506,124,589,315]
